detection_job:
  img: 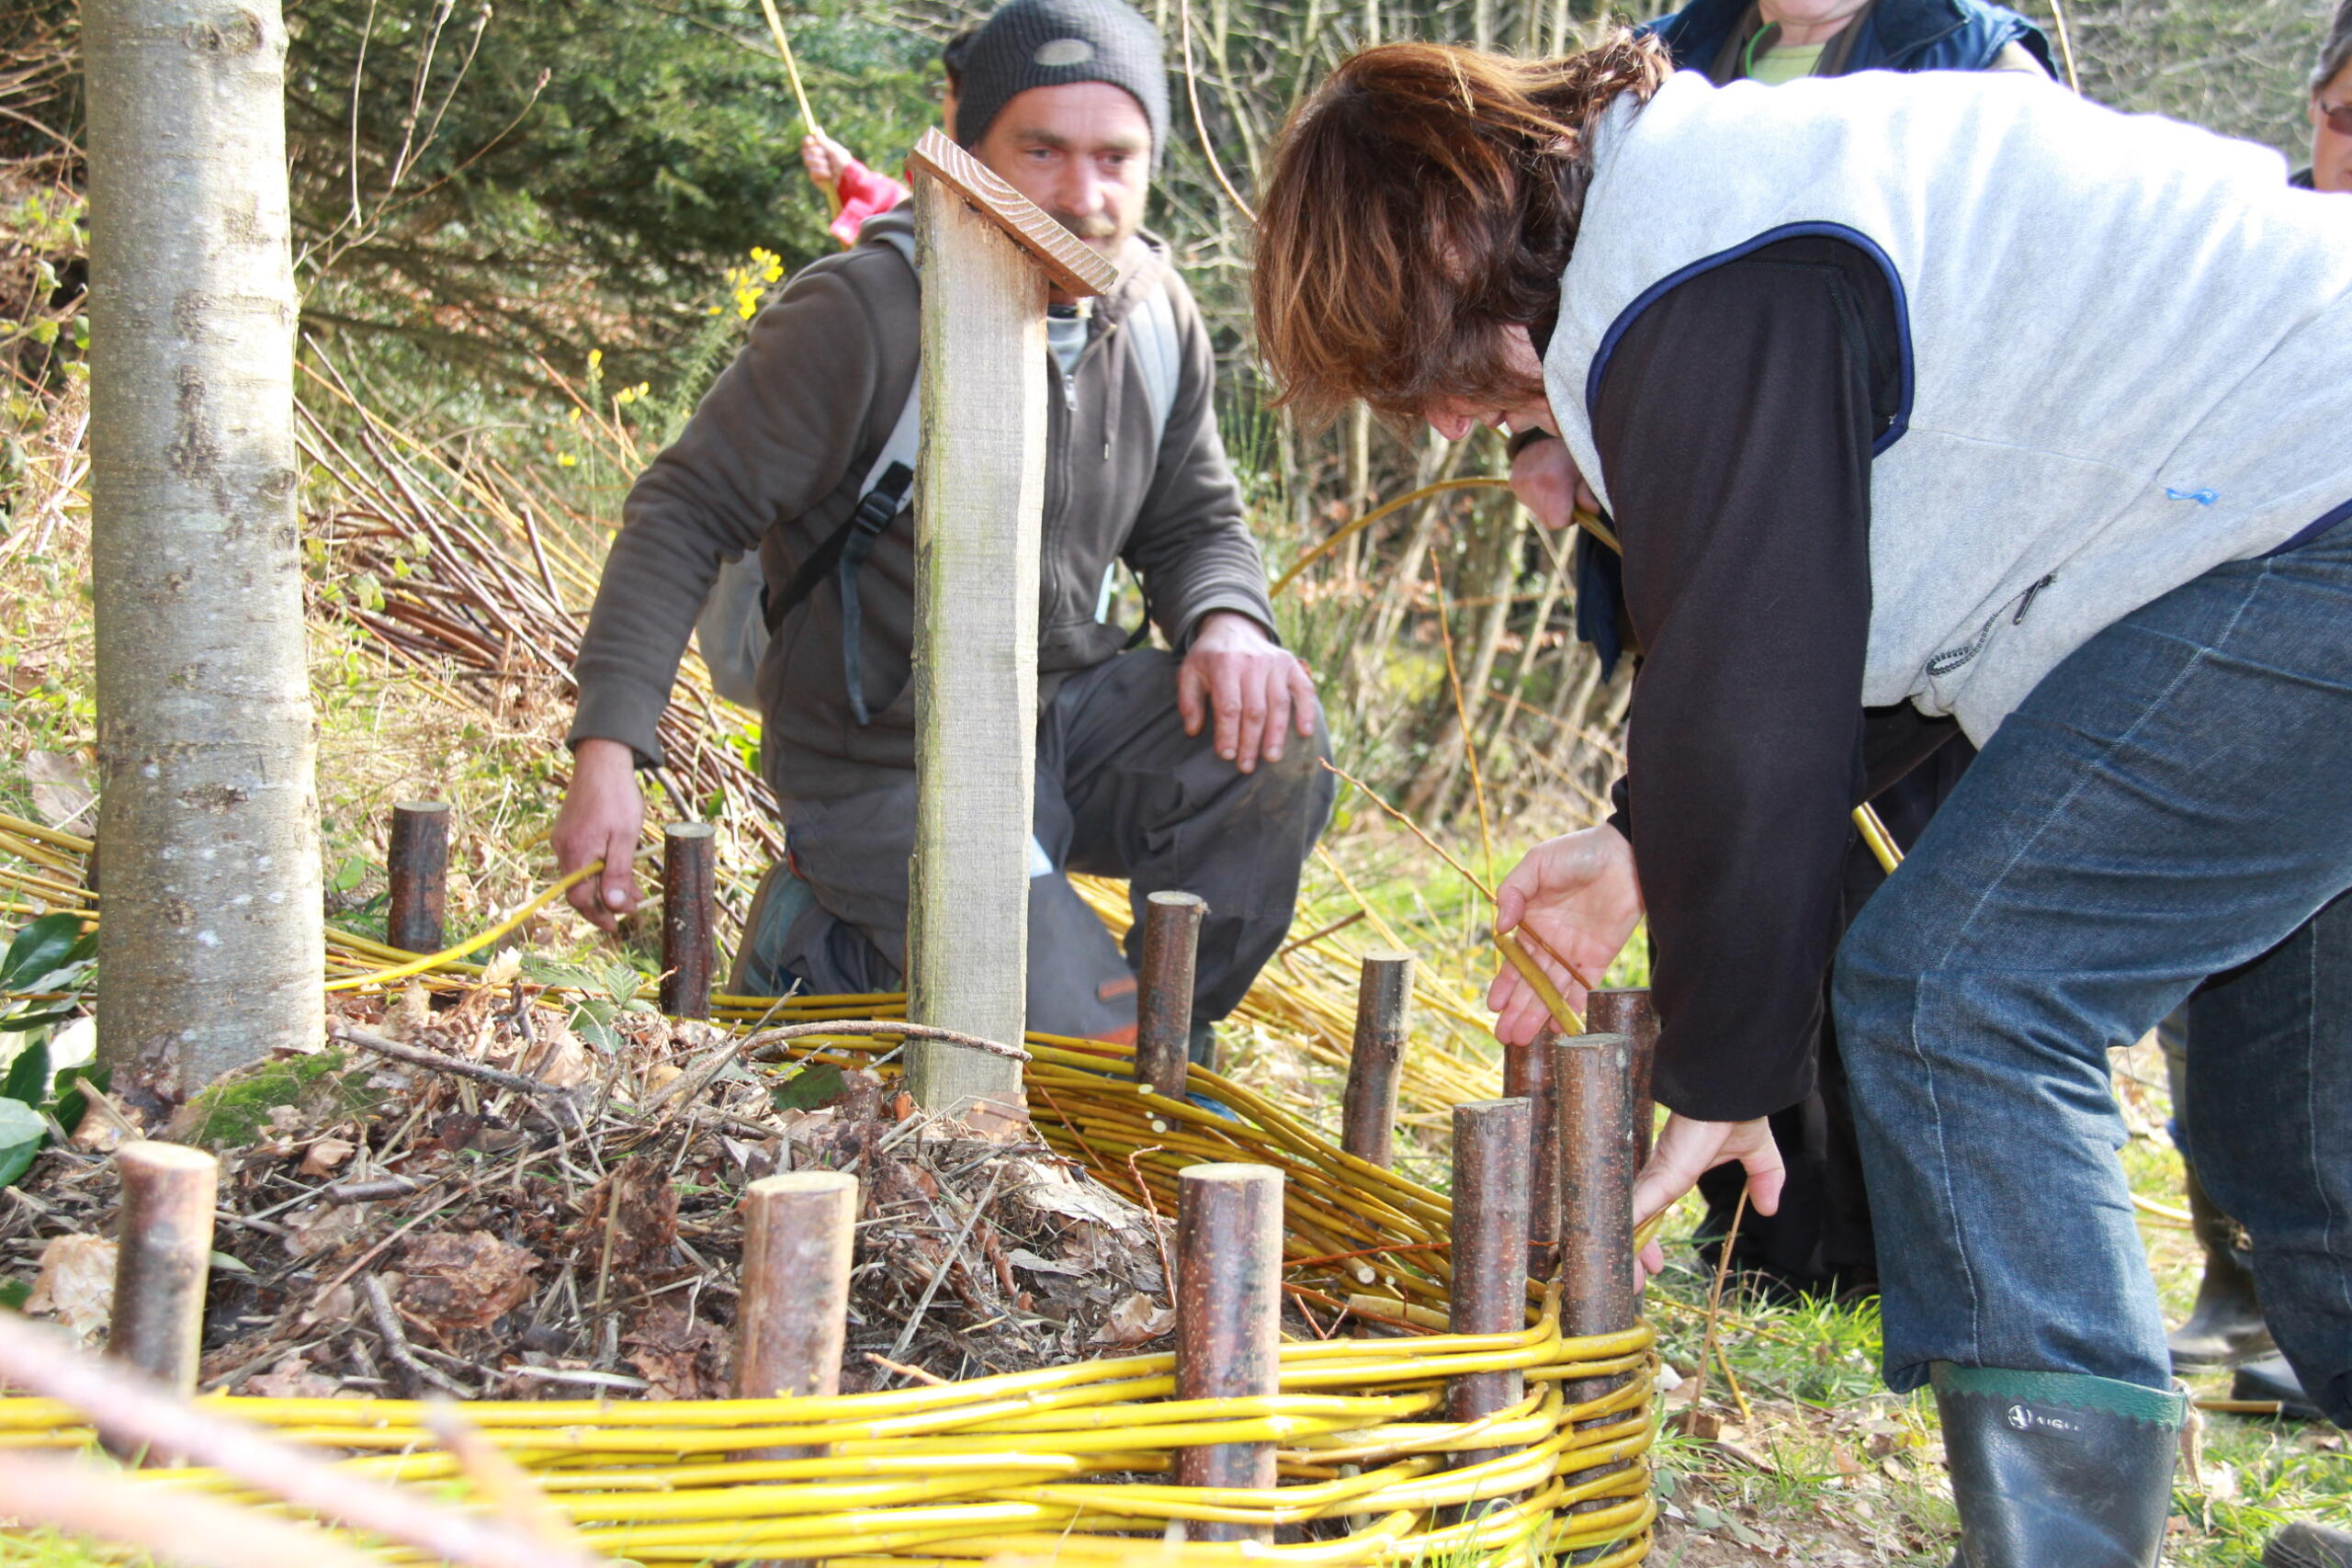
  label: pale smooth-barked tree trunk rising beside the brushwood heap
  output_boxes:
[83,0,322,1100]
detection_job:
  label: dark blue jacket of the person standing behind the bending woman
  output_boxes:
[1576,0,2058,674]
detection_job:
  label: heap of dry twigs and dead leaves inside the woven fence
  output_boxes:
[0,983,1171,1399]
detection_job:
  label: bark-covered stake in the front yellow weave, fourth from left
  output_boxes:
[1446,1100,1532,1464]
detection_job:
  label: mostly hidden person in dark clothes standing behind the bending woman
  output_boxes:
[1510,0,2051,1295]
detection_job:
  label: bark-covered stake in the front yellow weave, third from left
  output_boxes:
[1176,1164,1282,1540]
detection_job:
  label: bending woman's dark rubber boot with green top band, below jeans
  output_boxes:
[1936,1361,2189,1568]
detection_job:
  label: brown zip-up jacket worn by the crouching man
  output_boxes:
[571,209,1272,799]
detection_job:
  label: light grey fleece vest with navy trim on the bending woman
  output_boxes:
[1543,71,2352,743]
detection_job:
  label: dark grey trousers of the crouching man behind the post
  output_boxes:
[731,649,1334,1039]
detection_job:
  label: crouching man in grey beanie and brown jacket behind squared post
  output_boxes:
[553,0,1331,1058]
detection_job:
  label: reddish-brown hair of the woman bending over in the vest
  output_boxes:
[1251,30,1672,428]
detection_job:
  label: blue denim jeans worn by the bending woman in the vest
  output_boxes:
[1835,525,2352,1425]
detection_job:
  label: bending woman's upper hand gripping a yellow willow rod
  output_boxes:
[1487,825,1642,1046]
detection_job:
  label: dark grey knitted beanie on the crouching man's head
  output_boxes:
[955,0,1169,164]
